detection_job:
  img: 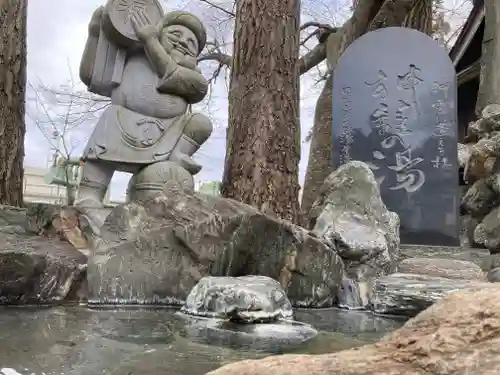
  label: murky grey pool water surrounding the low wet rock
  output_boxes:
[0,307,402,375]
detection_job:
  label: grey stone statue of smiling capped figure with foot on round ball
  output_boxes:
[75,0,212,207]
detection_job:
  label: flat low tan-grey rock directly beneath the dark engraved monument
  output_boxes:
[398,258,484,280]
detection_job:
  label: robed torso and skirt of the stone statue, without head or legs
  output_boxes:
[83,54,207,173]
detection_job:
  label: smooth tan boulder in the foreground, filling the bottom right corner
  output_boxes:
[209,284,500,375]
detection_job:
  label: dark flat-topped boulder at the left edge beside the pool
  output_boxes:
[0,233,87,304]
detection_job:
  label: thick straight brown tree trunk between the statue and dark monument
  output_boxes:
[221,0,300,222]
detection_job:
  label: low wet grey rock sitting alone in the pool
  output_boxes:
[181,276,293,323]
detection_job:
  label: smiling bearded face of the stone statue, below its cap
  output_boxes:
[161,25,198,69]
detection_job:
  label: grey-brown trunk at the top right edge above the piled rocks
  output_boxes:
[476,0,500,115]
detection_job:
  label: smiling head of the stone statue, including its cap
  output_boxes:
[160,11,207,69]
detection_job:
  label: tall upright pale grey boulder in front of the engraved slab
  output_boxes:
[312,161,400,307]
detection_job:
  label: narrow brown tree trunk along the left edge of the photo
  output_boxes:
[0,0,27,207]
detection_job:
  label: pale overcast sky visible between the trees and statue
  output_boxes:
[25,0,468,199]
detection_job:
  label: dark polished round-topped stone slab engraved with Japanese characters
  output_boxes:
[332,27,459,246]
